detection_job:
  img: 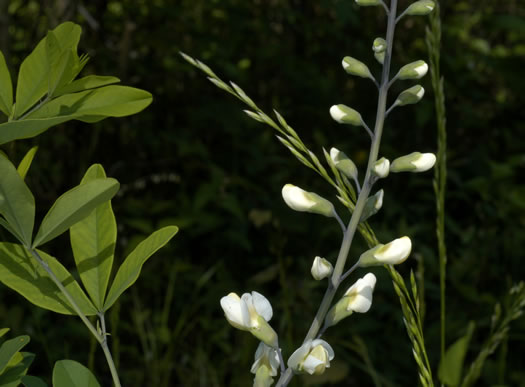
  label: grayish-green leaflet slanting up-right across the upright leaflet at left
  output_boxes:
[33,178,119,248]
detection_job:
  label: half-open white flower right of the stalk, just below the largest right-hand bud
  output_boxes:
[325,273,377,327]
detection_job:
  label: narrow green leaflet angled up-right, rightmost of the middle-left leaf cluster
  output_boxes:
[104,226,179,311]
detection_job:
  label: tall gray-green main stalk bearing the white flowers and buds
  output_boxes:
[276,0,397,387]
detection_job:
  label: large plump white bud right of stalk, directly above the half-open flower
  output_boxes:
[359,236,412,267]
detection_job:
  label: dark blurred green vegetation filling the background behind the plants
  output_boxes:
[0,0,525,386]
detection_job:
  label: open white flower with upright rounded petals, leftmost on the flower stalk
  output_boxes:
[221,291,277,348]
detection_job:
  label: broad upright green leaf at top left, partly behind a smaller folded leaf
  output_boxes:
[14,22,81,119]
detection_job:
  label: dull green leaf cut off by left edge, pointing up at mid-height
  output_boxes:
[0,157,35,246]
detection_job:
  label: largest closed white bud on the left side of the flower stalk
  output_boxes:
[282,184,335,217]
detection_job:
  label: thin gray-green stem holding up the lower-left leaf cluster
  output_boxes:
[26,247,121,387]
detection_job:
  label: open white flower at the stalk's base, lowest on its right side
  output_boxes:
[288,339,334,375]
